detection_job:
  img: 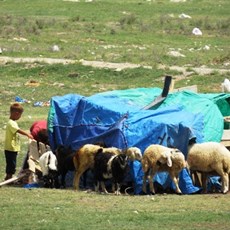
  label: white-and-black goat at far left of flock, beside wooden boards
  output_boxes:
[39,151,59,188]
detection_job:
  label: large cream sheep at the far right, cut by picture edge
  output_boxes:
[187,142,230,194]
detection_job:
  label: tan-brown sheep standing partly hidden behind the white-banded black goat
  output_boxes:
[73,144,142,190]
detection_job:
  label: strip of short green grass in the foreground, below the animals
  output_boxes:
[0,187,230,230]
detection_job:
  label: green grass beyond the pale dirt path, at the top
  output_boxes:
[0,0,230,66]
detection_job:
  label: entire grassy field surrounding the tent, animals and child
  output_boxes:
[0,0,230,230]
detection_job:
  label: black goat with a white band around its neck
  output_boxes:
[94,149,128,195]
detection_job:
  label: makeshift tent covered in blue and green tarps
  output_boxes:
[48,88,228,194]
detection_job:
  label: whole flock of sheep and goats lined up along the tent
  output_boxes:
[39,141,230,194]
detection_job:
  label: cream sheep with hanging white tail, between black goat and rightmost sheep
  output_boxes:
[141,144,186,195]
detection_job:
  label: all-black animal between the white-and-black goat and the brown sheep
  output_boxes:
[55,145,76,188]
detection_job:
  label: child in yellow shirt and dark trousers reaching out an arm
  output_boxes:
[5,103,33,180]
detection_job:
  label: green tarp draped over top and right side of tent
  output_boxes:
[99,88,230,142]
